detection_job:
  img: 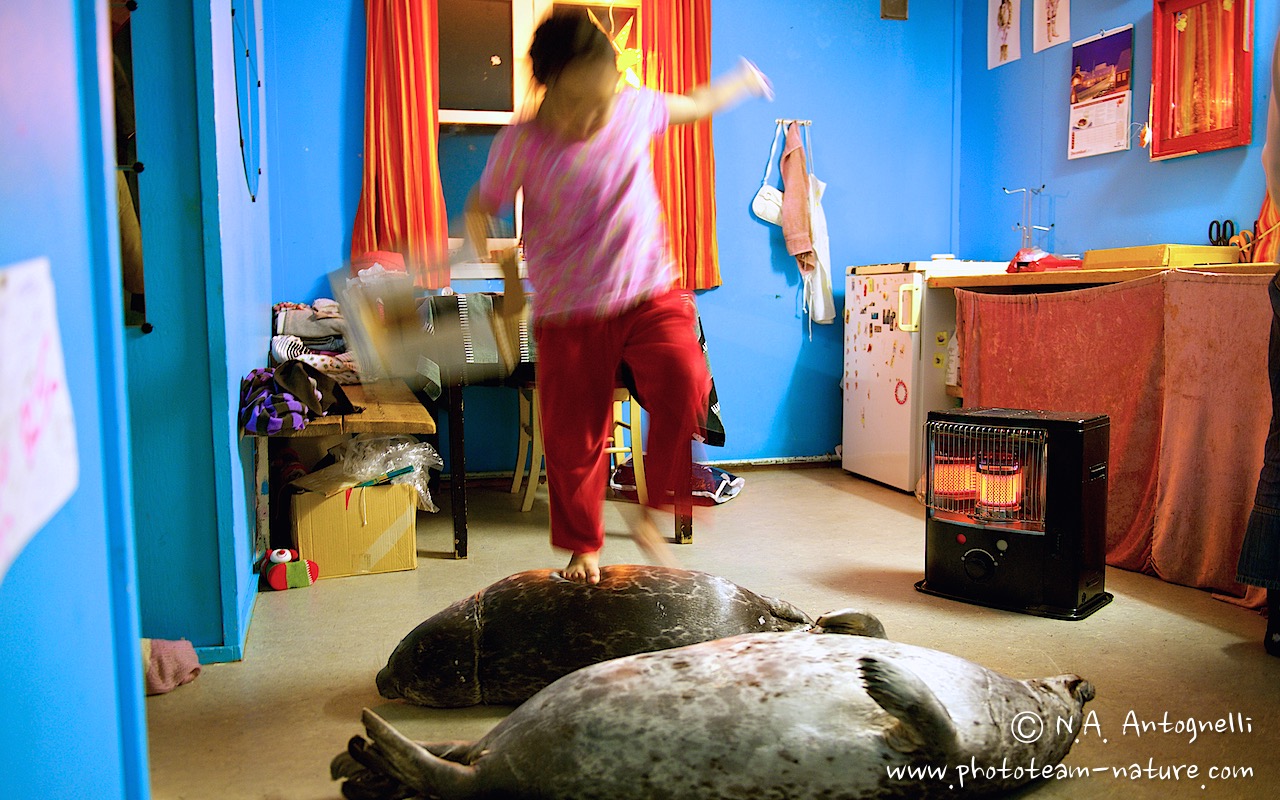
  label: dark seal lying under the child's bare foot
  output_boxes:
[378,564,813,708]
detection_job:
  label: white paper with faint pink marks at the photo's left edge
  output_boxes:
[0,259,79,581]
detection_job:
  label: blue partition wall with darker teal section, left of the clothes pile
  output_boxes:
[127,1,271,662]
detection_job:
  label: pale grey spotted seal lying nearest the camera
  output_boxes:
[333,632,1093,800]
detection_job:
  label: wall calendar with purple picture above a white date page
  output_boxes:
[1066,26,1133,159]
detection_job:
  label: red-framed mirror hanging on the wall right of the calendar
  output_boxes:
[1151,0,1253,160]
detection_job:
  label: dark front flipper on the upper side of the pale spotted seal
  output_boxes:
[858,655,956,755]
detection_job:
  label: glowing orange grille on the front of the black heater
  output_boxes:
[925,420,1048,532]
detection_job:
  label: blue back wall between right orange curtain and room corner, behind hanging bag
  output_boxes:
[699,0,955,461]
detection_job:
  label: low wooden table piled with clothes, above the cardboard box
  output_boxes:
[245,380,467,558]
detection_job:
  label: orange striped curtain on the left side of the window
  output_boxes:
[351,0,449,289]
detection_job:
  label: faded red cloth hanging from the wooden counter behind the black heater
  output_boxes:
[956,271,1271,607]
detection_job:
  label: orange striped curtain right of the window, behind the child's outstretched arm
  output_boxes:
[640,0,721,289]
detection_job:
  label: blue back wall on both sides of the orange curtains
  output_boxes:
[266,0,956,471]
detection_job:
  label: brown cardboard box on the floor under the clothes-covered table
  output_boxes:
[293,472,417,579]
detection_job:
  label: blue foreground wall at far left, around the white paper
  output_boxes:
[0,0,150,800]
